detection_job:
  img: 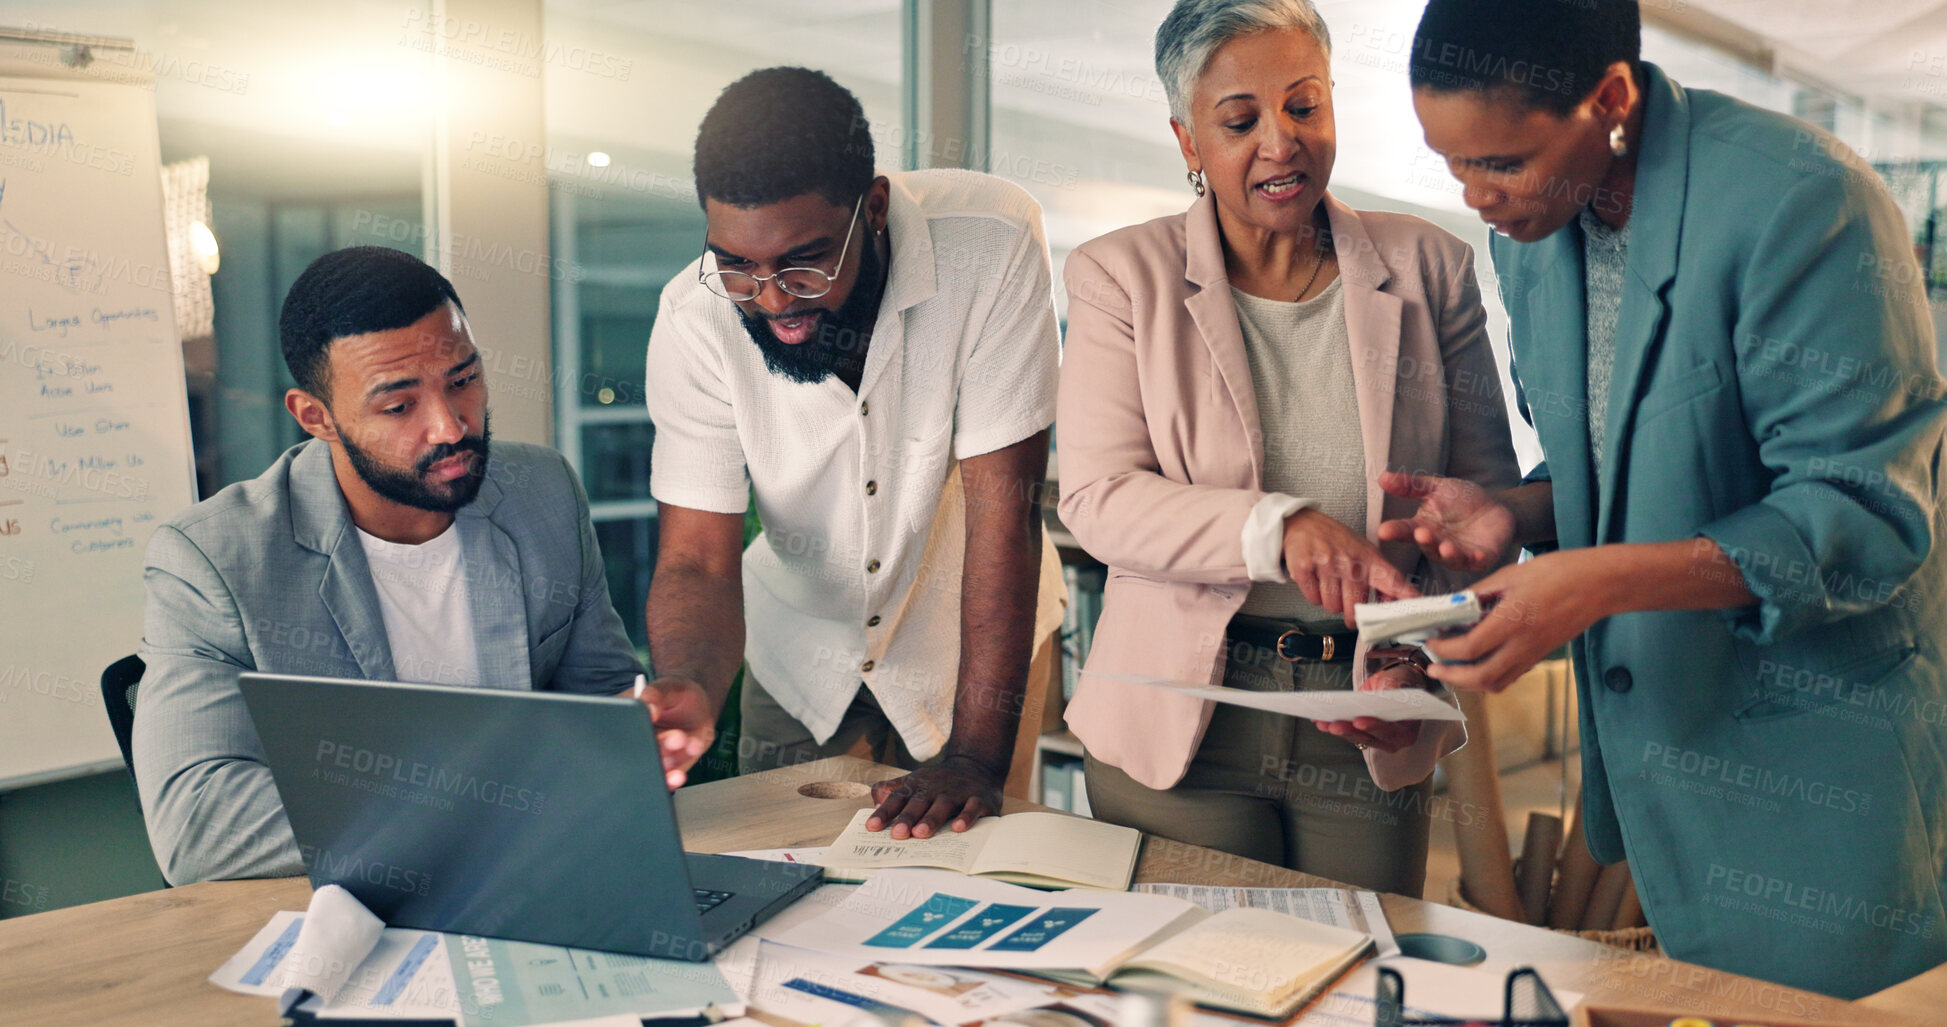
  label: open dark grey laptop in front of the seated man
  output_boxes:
[239,674,820,961]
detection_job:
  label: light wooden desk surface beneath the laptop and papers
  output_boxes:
[0,756,1947,1027]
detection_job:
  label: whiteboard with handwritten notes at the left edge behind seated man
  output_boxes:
[0,45,195,787]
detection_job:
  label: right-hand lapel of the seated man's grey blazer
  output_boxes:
[456,465,533,692]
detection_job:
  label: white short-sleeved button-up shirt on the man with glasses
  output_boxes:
[644,171,1065,760]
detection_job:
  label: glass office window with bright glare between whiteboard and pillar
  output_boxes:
[4,0,432,493]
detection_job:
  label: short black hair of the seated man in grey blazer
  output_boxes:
[276,246,467,407]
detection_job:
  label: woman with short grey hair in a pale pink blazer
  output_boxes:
[1057,0,1519,894]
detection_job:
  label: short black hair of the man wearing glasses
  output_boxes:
[695,68,874,207]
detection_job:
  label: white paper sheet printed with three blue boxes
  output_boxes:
[769,869,1205,970]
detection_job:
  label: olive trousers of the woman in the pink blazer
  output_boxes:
[1083,643,1431,898]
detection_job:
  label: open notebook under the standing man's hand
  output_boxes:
[824,809,1143,891]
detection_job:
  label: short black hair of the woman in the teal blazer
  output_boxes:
[1408,0,1643,117]
